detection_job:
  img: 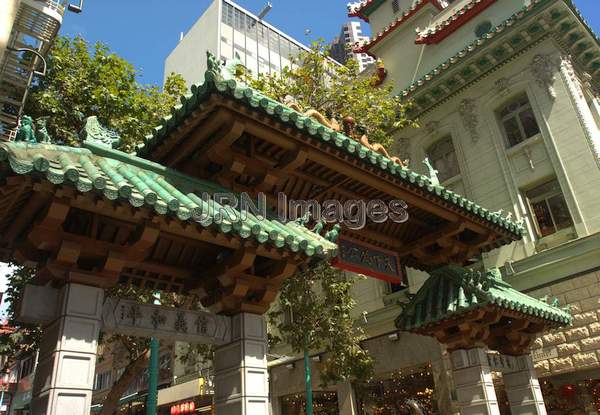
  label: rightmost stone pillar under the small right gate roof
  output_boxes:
[502,355,546,415]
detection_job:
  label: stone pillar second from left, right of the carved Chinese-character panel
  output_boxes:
[214,313,269,415]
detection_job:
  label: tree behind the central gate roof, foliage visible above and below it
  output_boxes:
[248,42,416,383]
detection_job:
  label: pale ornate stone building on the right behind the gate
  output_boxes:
[271,0,600,415]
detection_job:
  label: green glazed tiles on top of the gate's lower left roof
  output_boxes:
[0,141,337,257]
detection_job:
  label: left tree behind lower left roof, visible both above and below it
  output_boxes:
[0,37,189,414]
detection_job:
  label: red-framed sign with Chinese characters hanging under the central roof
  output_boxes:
[332,235,403,284]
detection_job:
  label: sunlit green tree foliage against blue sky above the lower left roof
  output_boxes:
[25,37,186,150]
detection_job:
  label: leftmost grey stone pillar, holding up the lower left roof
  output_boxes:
[32,284,104,415]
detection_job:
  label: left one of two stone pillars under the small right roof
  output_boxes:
[450,349,500,415]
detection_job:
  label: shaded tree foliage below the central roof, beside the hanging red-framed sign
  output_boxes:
[269,262,373,385]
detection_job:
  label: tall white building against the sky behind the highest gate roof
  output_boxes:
[165,0,307,86]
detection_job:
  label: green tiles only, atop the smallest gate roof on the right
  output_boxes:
[396,266,573,331]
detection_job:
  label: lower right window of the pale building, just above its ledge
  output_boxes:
[526,179,573,238]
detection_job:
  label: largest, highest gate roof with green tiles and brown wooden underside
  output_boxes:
[130,55,524,269]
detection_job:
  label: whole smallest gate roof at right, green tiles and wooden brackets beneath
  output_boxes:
[396,266,573,354]
